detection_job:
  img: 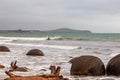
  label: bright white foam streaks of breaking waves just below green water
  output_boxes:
[0,36,78,49]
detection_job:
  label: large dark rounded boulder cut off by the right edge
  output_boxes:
[106,54,120,76]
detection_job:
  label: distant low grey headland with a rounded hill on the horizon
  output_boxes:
[0,28,92,34]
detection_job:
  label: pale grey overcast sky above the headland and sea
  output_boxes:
[0,0,120,33]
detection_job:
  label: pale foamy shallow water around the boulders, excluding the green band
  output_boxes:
[0,37,120,80]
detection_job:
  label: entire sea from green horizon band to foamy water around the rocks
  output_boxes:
[0,33,120,80]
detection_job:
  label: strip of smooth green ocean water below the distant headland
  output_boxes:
[0,32,120,41]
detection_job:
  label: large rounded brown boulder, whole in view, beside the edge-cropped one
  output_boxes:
[70,55,105,76]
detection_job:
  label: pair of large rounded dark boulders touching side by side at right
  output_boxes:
[69,54,120,76]
